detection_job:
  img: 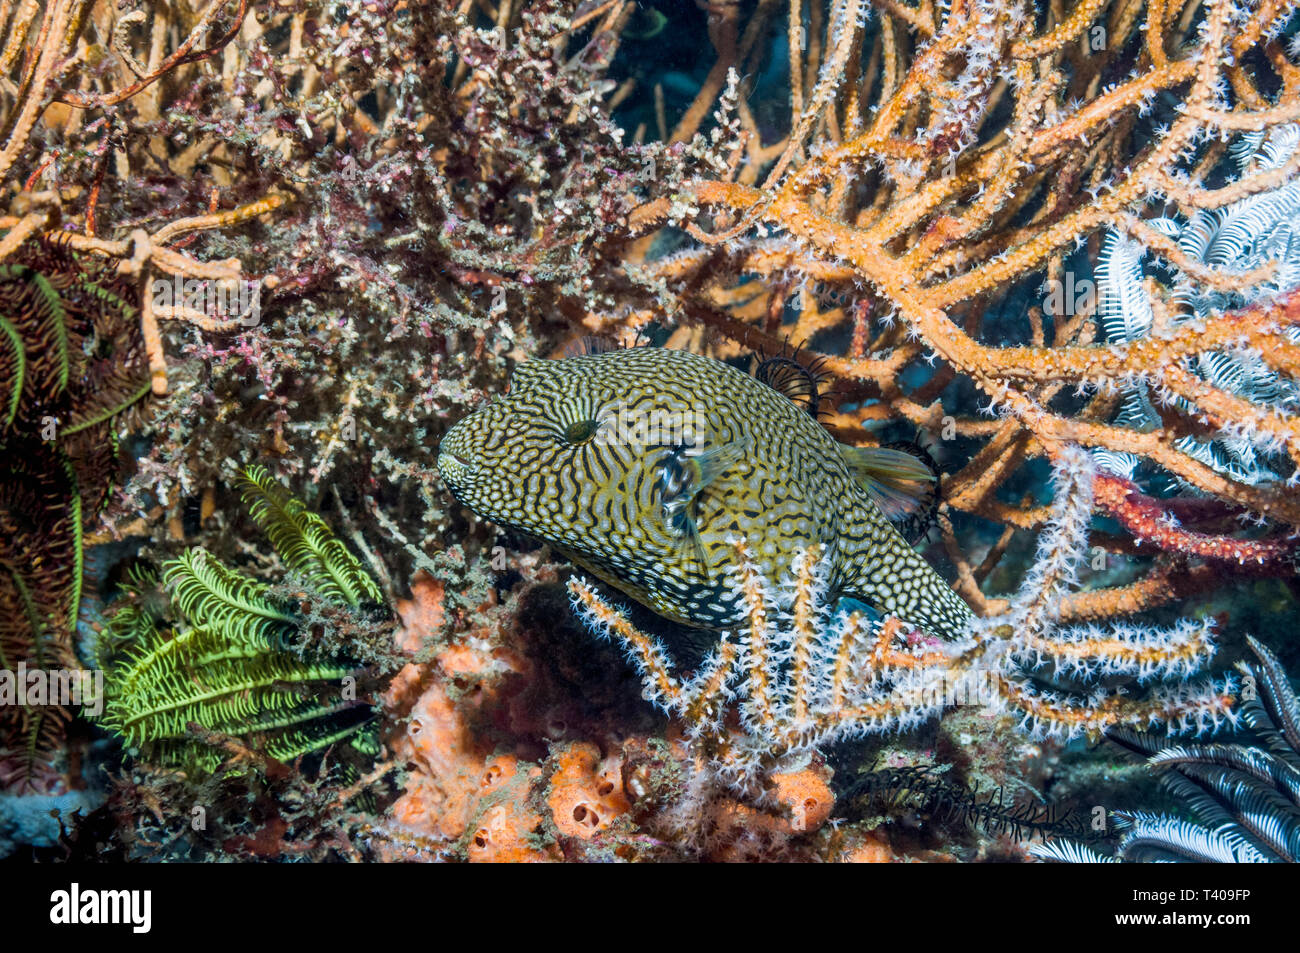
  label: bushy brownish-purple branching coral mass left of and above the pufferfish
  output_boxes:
[0,0,754,590]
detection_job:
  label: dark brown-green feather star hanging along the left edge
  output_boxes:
[0,242,150,793]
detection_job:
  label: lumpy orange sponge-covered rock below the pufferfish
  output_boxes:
[367,572,889,862]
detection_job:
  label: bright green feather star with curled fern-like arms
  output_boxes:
[101,467,382,774]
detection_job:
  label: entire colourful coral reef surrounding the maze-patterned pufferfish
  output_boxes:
[0,0,1300,861]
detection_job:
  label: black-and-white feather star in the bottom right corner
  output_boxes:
[1030,637,1300,863]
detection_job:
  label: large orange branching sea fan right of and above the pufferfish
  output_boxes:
[613,0,1300,631]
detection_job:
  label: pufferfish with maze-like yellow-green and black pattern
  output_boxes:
[438,347,971,638]
